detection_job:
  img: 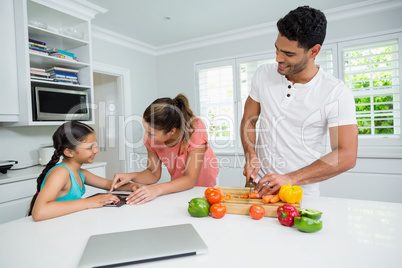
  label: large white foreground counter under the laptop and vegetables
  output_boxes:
[0,187,402,268]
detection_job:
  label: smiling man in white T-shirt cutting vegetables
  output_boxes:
[240,6,358,196]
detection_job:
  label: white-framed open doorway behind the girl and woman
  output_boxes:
[93,63,131,180]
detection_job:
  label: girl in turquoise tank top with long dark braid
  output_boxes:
[28,121,137,221]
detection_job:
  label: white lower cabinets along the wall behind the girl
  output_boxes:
[0,162,106,224]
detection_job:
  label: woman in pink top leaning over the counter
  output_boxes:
[110,94,219,205]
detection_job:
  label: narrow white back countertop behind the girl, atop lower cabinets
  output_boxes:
[0,162,106,185]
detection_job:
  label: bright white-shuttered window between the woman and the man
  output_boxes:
[196,54,275,149]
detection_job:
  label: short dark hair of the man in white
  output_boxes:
[276,6,327,50]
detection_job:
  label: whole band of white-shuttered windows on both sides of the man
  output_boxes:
[196,34,402,149]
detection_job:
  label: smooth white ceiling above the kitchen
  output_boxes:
[86,0,370,47]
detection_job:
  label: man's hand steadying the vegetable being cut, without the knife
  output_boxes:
[254,173,292,197]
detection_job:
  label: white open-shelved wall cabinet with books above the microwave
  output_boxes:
[7,0,106,126]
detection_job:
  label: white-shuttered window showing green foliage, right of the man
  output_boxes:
[340,36,400,138]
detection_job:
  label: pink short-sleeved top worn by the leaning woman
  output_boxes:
[144,119,219,187]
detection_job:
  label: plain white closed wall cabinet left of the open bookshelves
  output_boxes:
[0,0,19,122]
